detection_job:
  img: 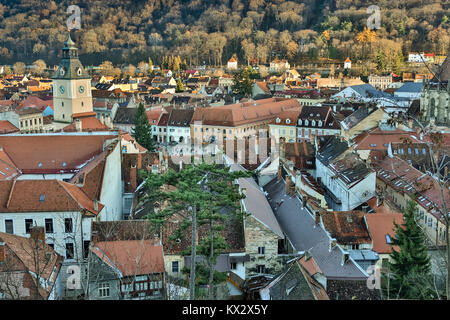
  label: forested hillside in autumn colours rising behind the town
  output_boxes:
[0,0,450,65]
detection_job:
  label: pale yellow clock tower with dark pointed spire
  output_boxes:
[52,33,93,123]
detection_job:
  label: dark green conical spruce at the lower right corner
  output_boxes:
[384,200,433,299]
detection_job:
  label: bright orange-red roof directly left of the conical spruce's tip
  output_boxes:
[366,213,404,254]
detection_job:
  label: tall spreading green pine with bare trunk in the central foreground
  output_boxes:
[145,163,251,300]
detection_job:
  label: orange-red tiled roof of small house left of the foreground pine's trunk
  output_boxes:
[91,240,165,277]
